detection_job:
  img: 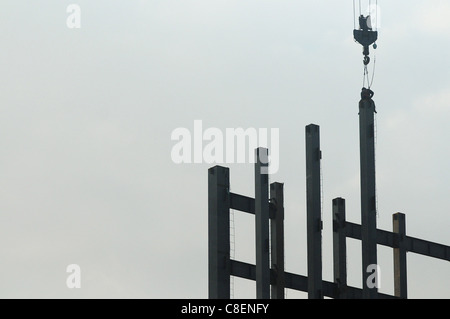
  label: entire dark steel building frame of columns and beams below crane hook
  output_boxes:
[208,90,450,299]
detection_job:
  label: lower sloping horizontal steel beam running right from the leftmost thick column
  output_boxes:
[231,260,398,299]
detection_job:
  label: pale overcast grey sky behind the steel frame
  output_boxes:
[0,0,450,298]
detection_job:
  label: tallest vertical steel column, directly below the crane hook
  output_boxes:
[359,98,378,299]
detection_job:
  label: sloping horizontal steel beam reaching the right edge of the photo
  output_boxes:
[345,222,450,261]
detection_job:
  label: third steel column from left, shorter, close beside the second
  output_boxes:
[270,183,285,299]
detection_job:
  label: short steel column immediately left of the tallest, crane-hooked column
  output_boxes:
[333,198,347,299]
